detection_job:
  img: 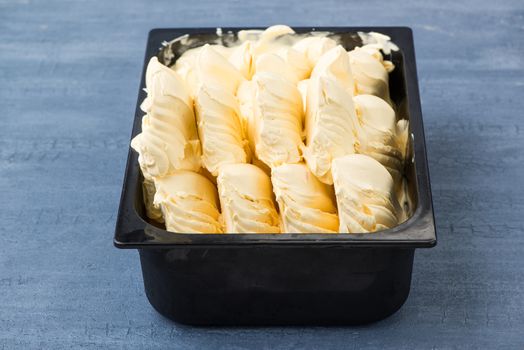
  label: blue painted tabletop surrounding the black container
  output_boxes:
[0,0,524,350]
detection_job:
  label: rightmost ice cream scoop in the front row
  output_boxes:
[331,154,400,233]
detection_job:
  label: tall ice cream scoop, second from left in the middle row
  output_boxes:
[195,45,250,176]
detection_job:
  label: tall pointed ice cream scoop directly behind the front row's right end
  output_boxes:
[303,46,357,184]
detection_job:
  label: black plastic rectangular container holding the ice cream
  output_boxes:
[114,27,436,325]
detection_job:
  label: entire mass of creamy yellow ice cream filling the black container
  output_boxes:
[132,25,409,233]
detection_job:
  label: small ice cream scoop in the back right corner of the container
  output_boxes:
[349,46,394,104]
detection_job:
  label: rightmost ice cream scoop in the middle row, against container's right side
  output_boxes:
[354,95,405,182]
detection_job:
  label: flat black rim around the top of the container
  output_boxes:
[113,27,437,249]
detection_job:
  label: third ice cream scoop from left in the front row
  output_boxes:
[271,163,339,233]
